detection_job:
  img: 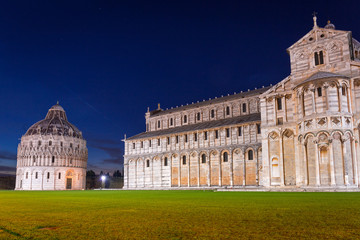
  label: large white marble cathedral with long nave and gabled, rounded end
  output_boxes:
[124,17,360,190]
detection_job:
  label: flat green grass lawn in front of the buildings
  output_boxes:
[0,191,360,239]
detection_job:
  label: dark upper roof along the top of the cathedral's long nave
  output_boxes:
[151,86,271,117]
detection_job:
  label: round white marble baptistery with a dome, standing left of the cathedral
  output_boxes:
[15,103,88,190]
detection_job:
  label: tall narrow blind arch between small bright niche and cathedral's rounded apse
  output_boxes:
[280,129,296,185]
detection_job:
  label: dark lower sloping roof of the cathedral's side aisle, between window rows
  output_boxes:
[127,113,261,140]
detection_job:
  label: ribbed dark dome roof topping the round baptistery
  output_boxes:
[25,103,83,139]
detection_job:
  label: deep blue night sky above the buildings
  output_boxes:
[0,0,360,173]
